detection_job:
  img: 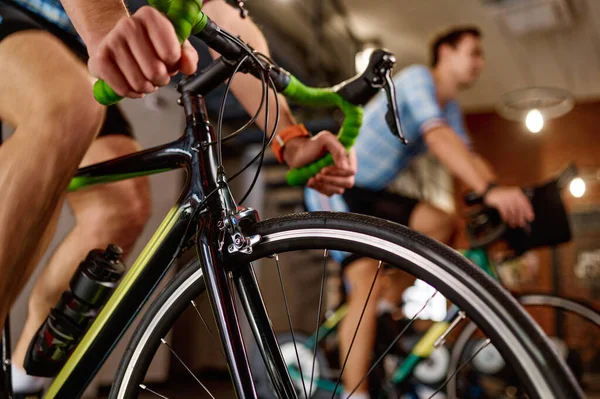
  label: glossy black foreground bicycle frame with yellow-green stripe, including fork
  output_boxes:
[19,92,296,398]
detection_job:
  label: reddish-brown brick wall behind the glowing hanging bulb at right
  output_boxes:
[466,102,600,212]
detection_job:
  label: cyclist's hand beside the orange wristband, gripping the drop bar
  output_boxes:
[283,131,356,195]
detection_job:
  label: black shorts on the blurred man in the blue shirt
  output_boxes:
[342,187,419,268]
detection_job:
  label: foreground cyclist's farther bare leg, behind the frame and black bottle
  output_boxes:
[13,135,150,382]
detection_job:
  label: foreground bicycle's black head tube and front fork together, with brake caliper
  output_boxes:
[186,93,297,399]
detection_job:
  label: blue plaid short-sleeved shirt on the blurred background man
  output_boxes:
[305,65,470,244]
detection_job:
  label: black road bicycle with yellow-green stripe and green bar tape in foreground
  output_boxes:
[2,0,582,399]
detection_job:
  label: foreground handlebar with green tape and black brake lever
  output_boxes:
[94,0,407,186]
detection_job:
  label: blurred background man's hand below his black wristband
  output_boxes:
[484,187,534,228]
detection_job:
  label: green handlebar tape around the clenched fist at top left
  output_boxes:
[94,0,208,105]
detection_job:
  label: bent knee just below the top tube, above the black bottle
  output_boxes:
[75,177,152,254]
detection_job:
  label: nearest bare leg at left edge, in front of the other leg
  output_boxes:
[0,31,105,327]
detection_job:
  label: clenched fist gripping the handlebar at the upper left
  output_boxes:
[88,6,198,98]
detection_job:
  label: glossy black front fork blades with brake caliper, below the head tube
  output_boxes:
[198,209,297,399]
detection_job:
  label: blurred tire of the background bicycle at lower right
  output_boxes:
[446,294,600,399]
